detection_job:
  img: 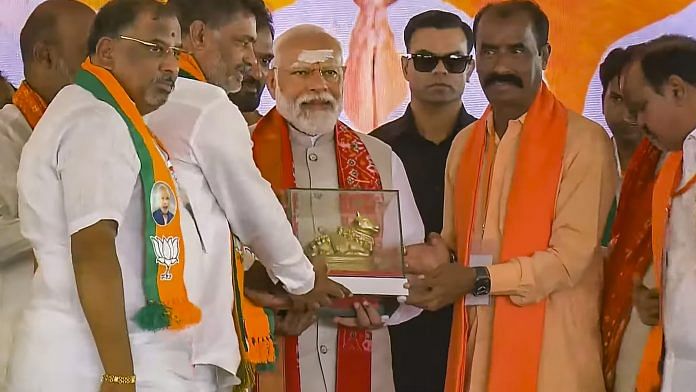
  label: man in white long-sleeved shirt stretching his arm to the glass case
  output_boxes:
[146,0,344,390]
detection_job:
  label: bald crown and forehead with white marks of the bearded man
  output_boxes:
[273,24,343,67]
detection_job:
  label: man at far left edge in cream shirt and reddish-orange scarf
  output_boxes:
[0,0,94,389]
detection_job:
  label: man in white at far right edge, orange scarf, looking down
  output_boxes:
[622,36,696,392]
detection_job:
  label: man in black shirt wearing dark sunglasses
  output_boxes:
[370,10,476,392]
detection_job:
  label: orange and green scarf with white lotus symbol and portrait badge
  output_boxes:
[75,58,201,331]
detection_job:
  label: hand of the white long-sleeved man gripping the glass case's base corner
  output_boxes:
[290,260,351,311]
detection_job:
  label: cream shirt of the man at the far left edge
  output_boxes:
[0,105,34,391]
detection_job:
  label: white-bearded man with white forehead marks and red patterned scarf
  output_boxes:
[252,25,424,392]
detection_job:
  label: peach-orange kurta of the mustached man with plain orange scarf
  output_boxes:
[442,112,617,392]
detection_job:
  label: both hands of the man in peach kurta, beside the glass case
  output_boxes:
[404,233,476,311]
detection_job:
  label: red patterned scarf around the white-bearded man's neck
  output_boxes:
[252,108,382,392]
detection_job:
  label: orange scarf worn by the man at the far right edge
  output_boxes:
[636,151,696,392]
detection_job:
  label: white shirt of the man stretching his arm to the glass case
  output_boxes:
[146,78,314,373]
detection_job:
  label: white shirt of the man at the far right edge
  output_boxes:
[662,130,696,392]
